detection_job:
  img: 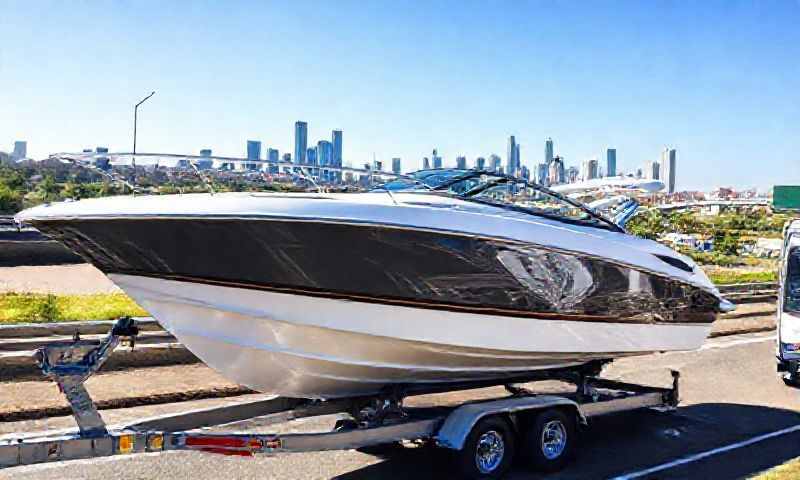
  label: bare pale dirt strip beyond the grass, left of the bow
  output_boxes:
[0,263,120,294]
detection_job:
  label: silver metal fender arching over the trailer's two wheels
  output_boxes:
[434,395,586,450]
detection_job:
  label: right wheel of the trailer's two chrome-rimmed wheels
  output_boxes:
[522,409,577,472]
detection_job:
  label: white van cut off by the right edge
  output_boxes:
[777,220,800,386]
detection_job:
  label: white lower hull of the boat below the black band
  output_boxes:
[109,274,711,398]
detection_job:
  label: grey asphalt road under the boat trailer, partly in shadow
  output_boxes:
[0,333,800,480]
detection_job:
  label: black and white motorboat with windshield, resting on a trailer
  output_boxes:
[16,159,730,399]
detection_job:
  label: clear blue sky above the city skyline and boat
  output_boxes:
[0,0,800,189]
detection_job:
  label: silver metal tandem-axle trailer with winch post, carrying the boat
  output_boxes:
[0,318,680,478]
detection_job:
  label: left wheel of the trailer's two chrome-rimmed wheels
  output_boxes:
[456,416,515,479]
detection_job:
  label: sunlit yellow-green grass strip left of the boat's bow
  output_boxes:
[0,293,147,324]
